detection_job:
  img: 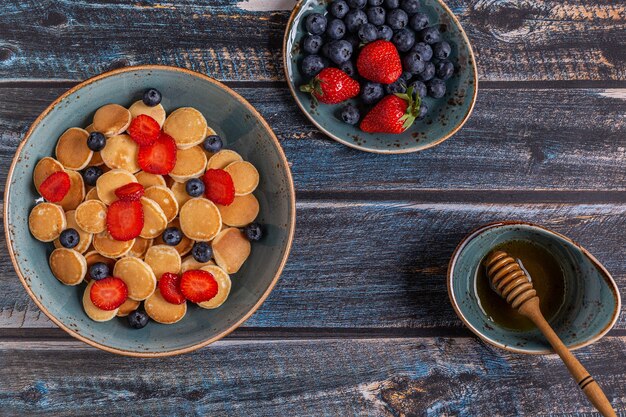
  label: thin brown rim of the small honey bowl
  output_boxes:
[446,221,622,355]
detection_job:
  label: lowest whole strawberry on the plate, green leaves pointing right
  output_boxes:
[360,88,420,134]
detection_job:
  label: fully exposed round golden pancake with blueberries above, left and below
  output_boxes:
[179,198,222,241]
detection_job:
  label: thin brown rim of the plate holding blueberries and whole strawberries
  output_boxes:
[283,0,478,154]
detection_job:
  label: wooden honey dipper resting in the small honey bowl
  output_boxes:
[484,251,617,417]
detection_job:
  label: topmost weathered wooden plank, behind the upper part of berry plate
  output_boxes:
[0,0,626,81]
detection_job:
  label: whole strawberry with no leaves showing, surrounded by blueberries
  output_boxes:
[356,39,402,84]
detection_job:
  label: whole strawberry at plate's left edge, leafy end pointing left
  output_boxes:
[300,68,361,104]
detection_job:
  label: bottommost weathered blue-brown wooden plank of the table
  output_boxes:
[0,337,626,417]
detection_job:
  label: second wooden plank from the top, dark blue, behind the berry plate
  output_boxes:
[0,84,626,193]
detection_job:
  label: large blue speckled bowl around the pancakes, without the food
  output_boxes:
[4,65,295,357]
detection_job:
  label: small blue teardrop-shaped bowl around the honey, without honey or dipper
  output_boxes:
[448,222,621,354]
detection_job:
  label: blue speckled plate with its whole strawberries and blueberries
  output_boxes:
[283,0,478,153]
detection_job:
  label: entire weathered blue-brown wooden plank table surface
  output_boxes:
[0,0,626,417]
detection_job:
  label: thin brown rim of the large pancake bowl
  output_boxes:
[4,65,296,357]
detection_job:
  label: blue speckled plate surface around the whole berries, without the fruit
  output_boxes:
[283,0,478,153]
